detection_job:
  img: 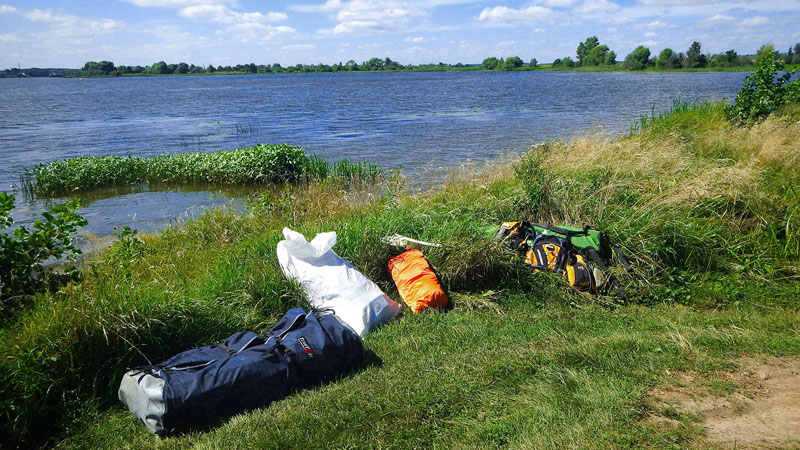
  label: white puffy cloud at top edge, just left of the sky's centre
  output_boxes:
[314,0,427,34]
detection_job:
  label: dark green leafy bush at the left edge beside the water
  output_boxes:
[0,192,86,315]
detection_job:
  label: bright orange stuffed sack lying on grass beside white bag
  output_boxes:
[389,248,447,313]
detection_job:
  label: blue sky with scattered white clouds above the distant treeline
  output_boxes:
[0,0,800,69]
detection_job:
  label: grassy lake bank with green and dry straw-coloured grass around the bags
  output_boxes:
[0,103,800,449]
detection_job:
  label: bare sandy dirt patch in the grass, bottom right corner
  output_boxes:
[649,357,800,448]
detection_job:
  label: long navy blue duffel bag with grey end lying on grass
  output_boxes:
[119,308,364,434]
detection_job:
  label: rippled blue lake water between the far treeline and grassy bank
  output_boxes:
[0,72,746,236]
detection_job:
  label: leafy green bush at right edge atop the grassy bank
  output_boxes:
[725,52,800,124]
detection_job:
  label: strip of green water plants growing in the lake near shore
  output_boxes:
[23,144,382,196]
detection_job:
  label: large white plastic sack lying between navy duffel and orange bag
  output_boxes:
[277,228,402,337]
